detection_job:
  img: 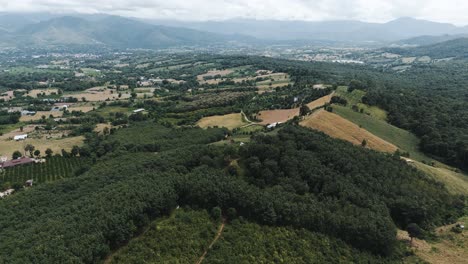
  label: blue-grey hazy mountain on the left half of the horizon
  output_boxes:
[0,16,252,48]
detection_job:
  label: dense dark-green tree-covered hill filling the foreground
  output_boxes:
[0,121,464,263]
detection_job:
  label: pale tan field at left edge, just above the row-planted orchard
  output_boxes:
[0,136,84,158]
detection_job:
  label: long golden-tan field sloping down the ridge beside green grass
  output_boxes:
[301,110,398,153]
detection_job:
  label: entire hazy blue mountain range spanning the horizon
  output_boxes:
[0,13,468,49]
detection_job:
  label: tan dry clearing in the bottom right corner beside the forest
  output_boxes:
[397,217,468,264]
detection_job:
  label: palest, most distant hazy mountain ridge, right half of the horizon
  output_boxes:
[144,18,468,42]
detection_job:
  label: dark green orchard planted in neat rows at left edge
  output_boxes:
[0,157,89,185]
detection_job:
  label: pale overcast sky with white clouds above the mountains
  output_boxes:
[0,0,468,25]
